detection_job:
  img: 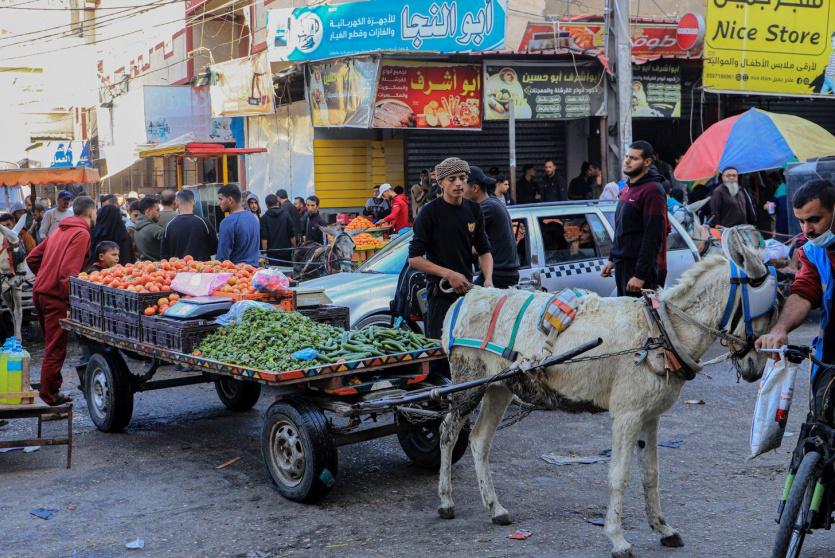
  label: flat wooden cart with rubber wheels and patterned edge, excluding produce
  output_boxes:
[62,320,468,502]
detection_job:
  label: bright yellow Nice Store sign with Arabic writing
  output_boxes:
[702,0,835,97]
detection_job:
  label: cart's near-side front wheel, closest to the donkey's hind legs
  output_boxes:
[261,398,339,504]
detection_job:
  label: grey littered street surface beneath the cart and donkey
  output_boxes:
[0,325,835,558]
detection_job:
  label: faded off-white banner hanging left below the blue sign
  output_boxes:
[209,52,275,117]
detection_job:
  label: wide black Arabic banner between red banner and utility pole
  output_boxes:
[484,60,606,120]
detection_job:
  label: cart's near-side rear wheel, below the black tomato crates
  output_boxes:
[84,353,133,432]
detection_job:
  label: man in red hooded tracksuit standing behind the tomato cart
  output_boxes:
[26,196,96,405]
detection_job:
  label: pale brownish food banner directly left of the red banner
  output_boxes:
[307,56,380,128]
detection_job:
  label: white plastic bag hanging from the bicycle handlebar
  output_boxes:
[748,358,797,459]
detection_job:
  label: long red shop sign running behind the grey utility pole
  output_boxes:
[518,18,694,58]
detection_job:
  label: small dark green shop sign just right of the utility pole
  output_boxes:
[632,62,681,118]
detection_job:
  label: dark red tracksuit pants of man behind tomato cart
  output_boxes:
[32,294,70,403]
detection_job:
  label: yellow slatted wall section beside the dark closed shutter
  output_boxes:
[313,139,406,208]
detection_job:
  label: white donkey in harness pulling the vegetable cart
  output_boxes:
[438,229,777,558]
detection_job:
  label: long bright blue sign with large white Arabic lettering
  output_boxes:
[267,0,507,62]
